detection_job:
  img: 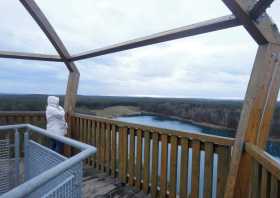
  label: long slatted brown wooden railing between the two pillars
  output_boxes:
[70,114,234,198]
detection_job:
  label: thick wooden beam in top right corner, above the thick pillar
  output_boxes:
[223,0,280,45]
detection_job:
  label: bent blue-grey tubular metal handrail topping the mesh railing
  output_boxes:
[0,124,96,198]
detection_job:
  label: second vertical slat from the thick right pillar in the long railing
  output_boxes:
[204,142,214,198]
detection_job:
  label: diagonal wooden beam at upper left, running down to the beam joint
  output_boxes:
[20,0,78,72]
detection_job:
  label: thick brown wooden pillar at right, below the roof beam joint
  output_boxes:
[224,44,280,198]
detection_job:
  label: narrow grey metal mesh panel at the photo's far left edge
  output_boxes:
[0,138,11,195]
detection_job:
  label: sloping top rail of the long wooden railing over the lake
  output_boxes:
[75,113,235,146]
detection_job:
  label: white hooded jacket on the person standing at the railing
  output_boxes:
[46,96,67,136]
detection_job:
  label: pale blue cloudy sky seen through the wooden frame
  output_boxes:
[0,0,280,99]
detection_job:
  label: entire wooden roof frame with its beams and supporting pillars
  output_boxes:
[0,0,280,198]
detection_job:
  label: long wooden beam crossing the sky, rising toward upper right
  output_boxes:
[70,15,240,61]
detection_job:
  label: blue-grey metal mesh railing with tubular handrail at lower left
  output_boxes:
[0,124,96,198]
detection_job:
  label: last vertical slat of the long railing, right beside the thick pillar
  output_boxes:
[216,146,230,198]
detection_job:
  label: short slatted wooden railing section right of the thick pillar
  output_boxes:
[245,143,280,198]
